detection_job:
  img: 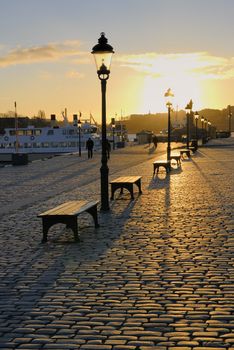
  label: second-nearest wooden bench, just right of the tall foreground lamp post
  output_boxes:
[110,176,142,199]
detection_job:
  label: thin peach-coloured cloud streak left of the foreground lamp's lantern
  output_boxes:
[0,41,83,67]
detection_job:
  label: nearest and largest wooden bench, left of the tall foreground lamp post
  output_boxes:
[38,200,99,243]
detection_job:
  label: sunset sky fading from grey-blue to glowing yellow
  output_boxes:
[0,0,234,122]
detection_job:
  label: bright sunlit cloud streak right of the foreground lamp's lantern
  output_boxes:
[116,52,234,79]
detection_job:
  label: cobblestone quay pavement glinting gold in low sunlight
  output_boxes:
[0,141,234,350]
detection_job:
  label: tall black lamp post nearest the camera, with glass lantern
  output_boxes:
[92,32,114,211]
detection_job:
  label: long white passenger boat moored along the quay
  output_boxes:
[0,113,101,155]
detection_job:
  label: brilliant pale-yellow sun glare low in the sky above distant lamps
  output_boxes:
[119,52,230,113]
